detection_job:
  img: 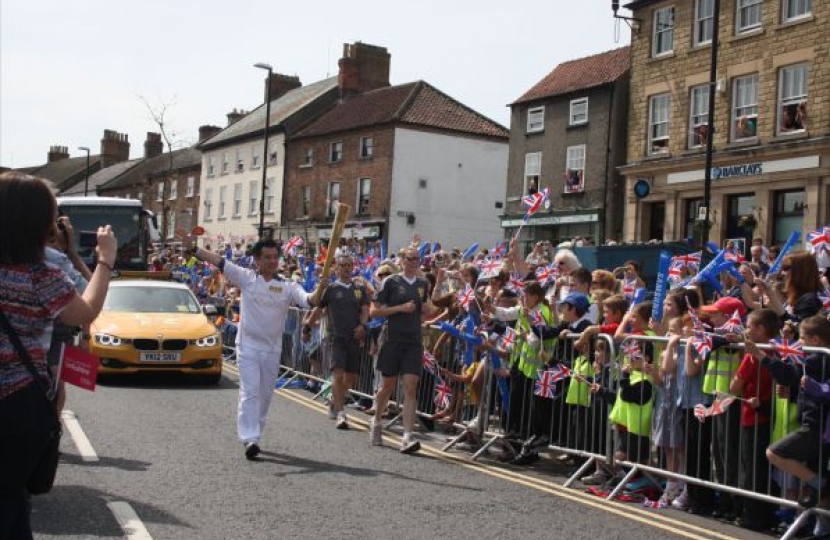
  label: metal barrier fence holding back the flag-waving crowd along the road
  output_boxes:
[223,309,830,539]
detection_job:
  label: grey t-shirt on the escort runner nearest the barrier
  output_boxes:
[375,274,429,343]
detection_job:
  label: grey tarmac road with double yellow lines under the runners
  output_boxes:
[33,370,769,540]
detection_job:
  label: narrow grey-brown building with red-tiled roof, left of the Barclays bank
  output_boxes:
[502,47,629,248]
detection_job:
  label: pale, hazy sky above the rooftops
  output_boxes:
[0,0,630,167]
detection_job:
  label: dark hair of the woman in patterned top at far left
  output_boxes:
[0,171,57,264]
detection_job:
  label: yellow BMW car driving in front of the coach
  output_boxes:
[89,280,222,384]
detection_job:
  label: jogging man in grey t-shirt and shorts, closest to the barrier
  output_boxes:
[369,248,432,454]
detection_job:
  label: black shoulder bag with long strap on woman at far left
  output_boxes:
[0,311,63,495]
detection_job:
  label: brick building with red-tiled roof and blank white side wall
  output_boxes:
[279,43,508,249]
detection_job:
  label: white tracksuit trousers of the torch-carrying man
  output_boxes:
[236,345,281,443]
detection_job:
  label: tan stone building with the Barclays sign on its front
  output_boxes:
[621,0,830,249]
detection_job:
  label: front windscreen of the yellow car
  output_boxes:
[104,286,202,313]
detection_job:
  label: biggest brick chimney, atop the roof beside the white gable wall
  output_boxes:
[337,41,392,97]
